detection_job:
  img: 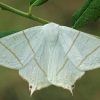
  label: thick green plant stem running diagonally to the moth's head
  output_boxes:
[0,2,49,24]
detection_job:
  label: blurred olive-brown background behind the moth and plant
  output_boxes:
[0,0,100,100]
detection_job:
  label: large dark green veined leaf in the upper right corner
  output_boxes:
[72,0,100,29]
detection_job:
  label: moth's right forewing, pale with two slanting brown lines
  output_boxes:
[60,26,100,71]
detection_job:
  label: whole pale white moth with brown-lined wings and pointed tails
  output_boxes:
[0,23,100,94]
